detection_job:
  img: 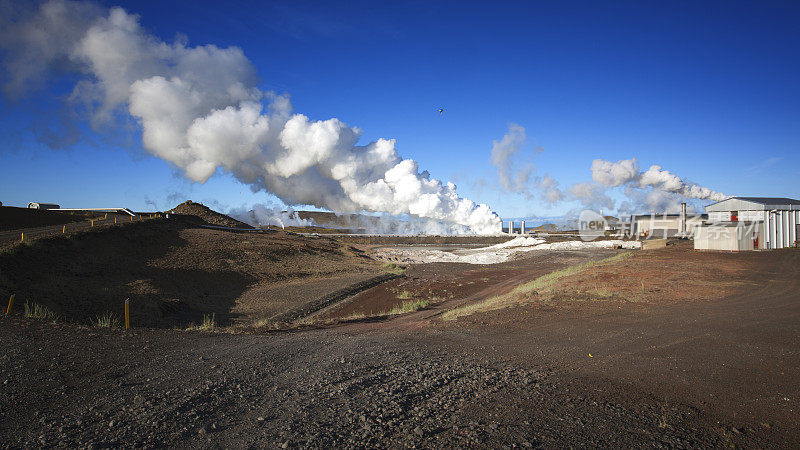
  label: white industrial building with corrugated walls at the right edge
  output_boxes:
[694,197,800,251]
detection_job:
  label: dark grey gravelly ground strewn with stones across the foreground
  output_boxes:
[0,319,744,448]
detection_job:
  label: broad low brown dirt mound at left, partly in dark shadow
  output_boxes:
[0,218,382,327]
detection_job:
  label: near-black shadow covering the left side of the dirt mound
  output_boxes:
[0,221,255,327]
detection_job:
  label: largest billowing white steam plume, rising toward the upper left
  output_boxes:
[2,0,500,233]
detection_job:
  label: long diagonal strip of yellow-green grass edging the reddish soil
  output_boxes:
[442,252,633,320]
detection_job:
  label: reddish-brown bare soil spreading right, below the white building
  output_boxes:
[338,243,800,446]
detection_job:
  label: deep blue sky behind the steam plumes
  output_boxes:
[0,1,800,217]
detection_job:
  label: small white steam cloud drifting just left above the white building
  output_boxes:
[591,158,728,201]
